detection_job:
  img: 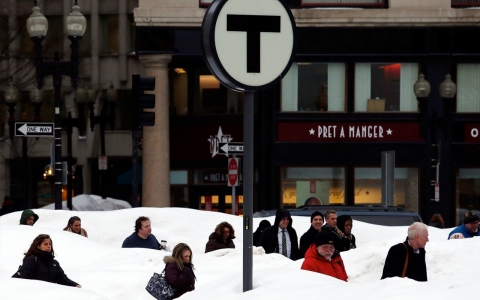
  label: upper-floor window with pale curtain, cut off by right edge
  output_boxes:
[457,64,480,113]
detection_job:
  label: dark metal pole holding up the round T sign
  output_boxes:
[243,91,254,292]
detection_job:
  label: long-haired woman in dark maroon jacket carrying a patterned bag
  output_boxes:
[163,243,196,299]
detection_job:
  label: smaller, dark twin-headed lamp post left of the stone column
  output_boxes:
[87,83,118,199]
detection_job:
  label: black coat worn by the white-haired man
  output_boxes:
[382,239,427,281]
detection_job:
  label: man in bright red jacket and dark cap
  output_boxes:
[302,231,348,281]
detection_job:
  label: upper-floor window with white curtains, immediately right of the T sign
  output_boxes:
[282,63,346,112]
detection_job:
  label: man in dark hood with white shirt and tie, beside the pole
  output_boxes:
[258,209,301,260]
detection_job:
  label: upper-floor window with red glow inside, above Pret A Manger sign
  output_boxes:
[355,63,419,112]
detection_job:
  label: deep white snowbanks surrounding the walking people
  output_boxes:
[0,195,480,300]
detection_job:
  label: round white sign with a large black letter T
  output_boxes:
[202,0,295,91]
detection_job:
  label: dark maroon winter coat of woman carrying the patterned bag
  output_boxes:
[163,256,196,299]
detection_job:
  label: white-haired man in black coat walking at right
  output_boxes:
[382,222,428,281]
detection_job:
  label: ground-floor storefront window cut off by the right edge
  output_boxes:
[455,168,480,224]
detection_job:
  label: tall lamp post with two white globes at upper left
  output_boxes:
[27,0,87,209]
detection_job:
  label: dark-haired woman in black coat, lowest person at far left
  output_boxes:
[15,234,81,288]
